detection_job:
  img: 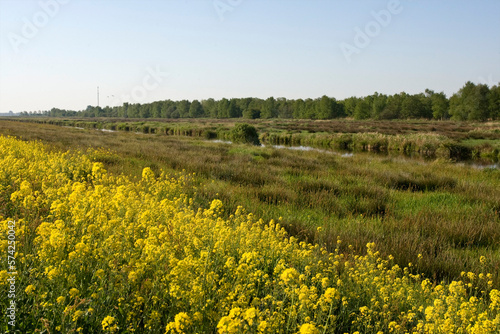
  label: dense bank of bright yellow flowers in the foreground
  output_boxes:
[0,137,500,333]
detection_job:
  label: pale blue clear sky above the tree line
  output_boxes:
[0,0,500,113]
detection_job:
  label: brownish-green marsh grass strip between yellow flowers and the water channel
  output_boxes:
[0,121,500,287]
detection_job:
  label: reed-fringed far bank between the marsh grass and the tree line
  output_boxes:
[10,118,500,162]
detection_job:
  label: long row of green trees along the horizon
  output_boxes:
[21,81,500,121]
